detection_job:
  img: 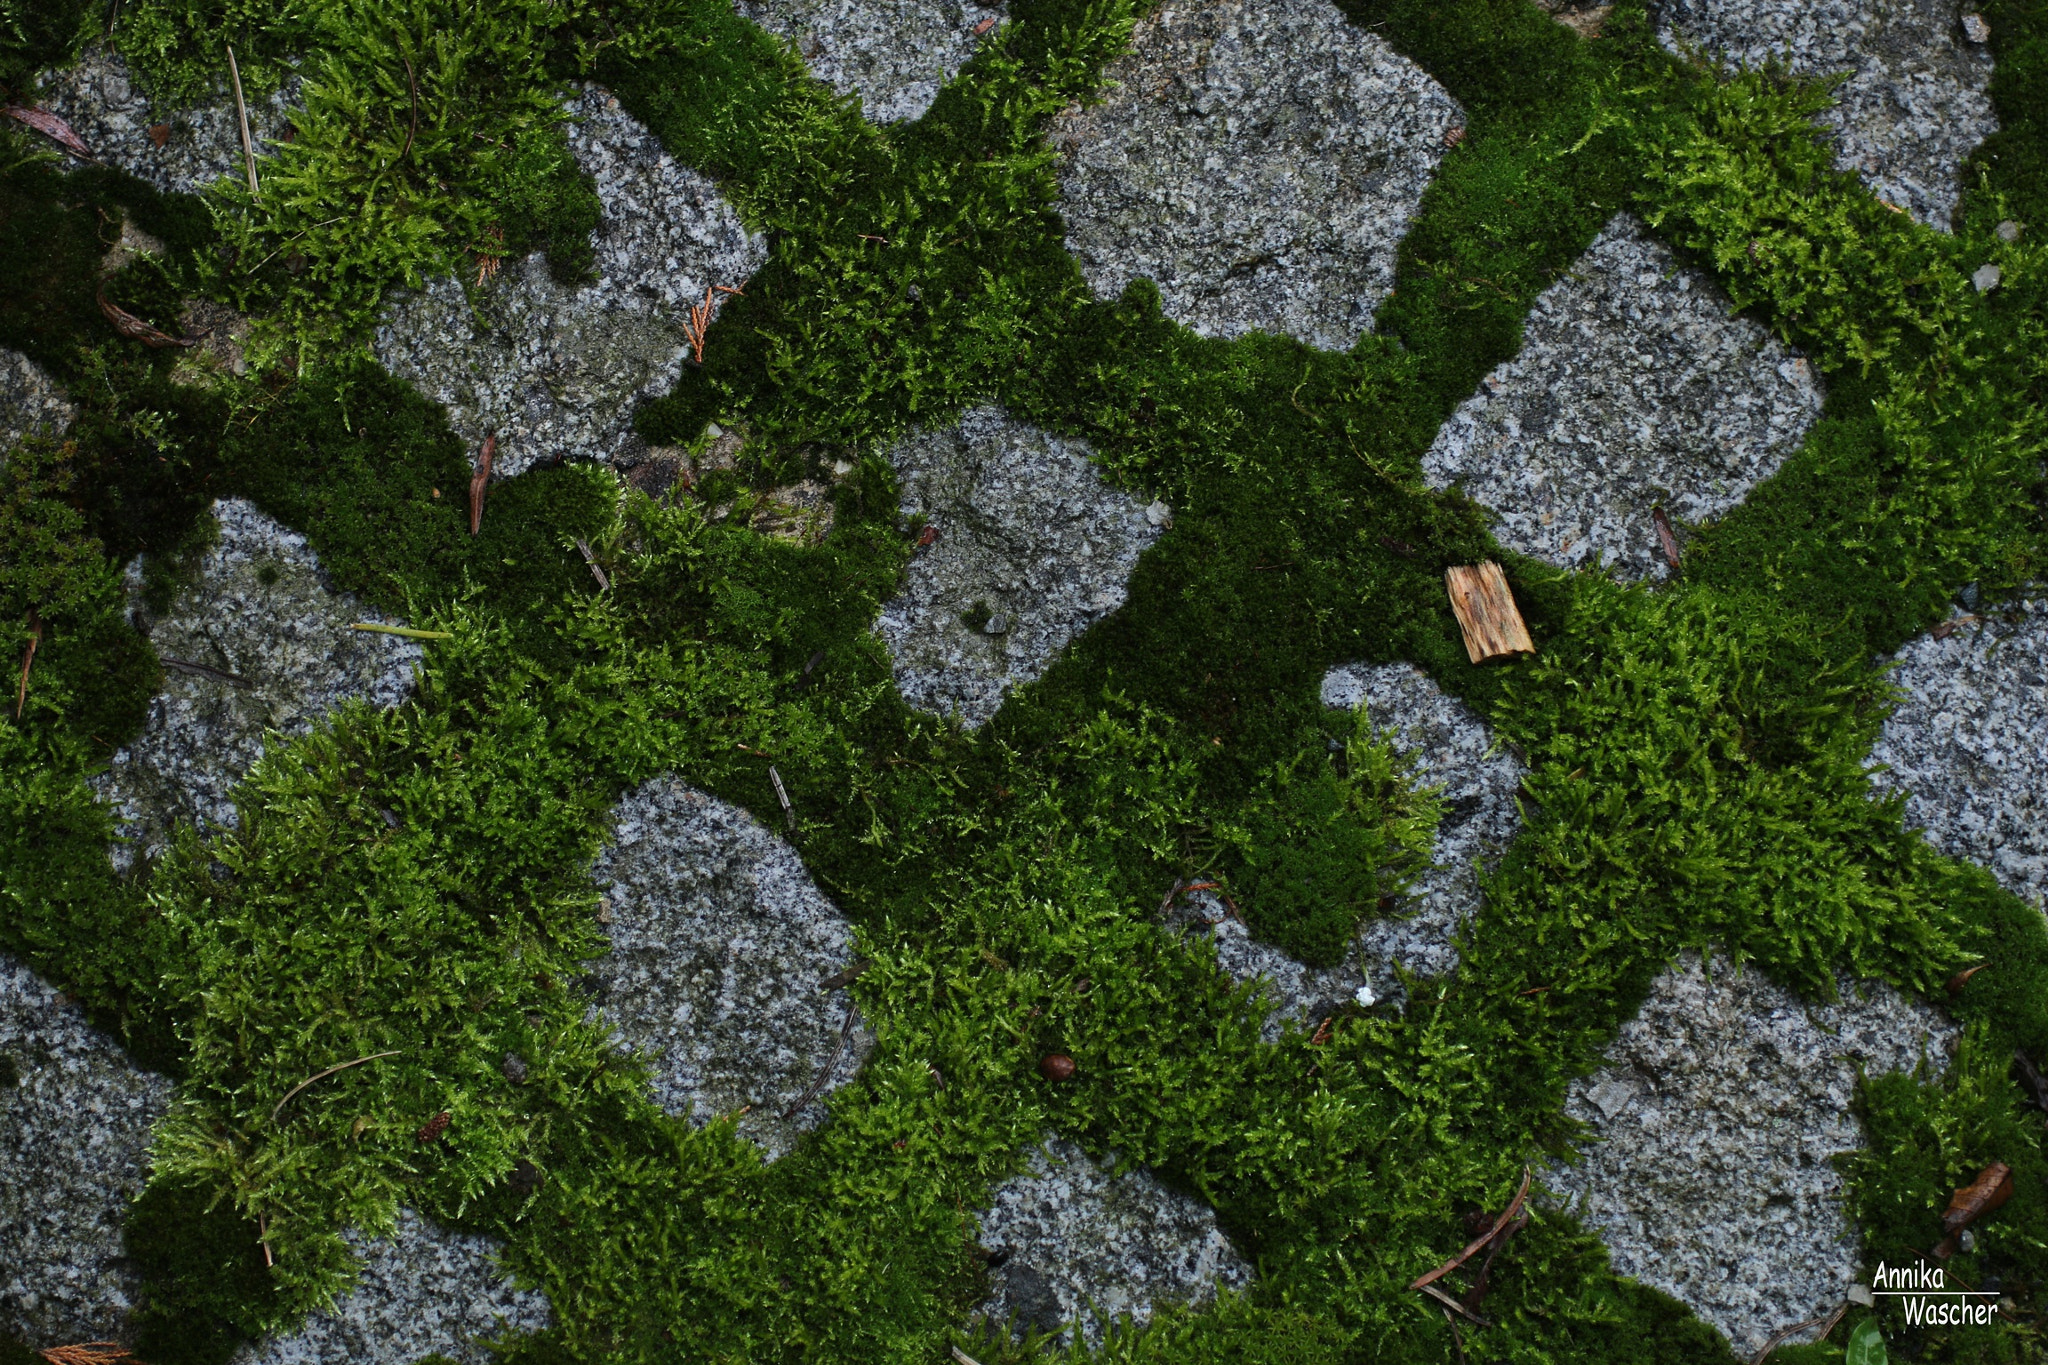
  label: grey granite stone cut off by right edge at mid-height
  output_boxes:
[1870,589,2048,907]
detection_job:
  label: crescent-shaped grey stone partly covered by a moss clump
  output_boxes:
[1167,663,1524,1042]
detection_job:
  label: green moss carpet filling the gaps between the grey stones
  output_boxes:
[0,0,2048,1363]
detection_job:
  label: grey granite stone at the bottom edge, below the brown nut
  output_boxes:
[981,1138,1251,1347]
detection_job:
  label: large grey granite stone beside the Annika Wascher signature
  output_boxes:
[1548,954,1956,1357]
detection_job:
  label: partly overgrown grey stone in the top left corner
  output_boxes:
[41,47,301,194]
